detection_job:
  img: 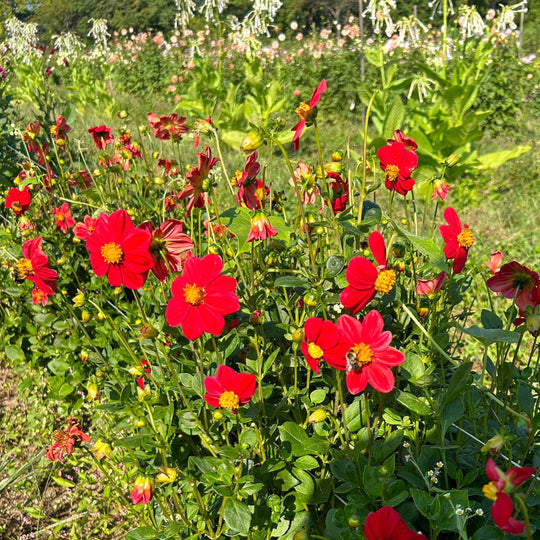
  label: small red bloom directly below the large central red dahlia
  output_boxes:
[204,364,257,414]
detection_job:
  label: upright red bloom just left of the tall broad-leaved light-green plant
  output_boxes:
[378,142,418,195]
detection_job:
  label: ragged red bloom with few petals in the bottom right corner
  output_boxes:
[482,458,535,534]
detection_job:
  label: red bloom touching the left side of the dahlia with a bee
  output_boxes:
[301,317,349,373]
